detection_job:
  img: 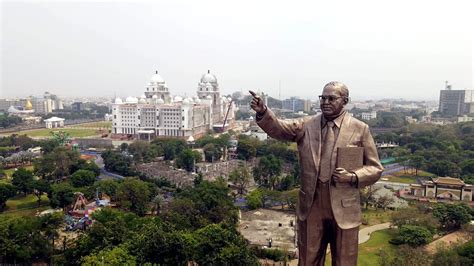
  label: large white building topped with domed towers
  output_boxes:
[112,71,235,138]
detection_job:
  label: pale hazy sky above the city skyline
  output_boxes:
[0,0,474,100]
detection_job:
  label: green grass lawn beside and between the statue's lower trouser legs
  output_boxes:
[325,229,397,266]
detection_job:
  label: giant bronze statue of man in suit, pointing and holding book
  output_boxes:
[250,82,383,265]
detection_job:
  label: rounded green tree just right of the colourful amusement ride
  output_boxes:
[117,179,151,216]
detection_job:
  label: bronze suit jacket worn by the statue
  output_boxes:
[257,109,383,229]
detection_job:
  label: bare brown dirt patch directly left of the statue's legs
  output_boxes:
[239,209,296,251]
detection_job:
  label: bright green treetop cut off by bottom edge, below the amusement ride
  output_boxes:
[82,246,137,266]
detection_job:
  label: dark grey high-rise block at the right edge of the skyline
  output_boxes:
[439,81,474,116]
